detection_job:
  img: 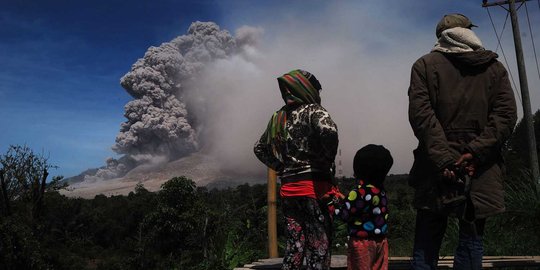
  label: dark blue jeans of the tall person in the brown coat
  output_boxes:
[411,210,485,270]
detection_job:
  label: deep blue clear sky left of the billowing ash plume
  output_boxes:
[0,1,219,176]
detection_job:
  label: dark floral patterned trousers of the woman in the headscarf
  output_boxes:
[282,197,332,270]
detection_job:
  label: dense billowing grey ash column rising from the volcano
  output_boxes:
[113,22,236,159]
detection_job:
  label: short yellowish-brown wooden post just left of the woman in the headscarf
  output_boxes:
[268,168,278,258]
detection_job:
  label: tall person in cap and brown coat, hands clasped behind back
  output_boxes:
[408,14,517,269]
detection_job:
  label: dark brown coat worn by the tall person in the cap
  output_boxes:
[408,50,517,218]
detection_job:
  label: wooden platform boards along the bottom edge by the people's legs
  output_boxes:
[234,255,540,270]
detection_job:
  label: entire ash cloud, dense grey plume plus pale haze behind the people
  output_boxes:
[78,11,418,184]
